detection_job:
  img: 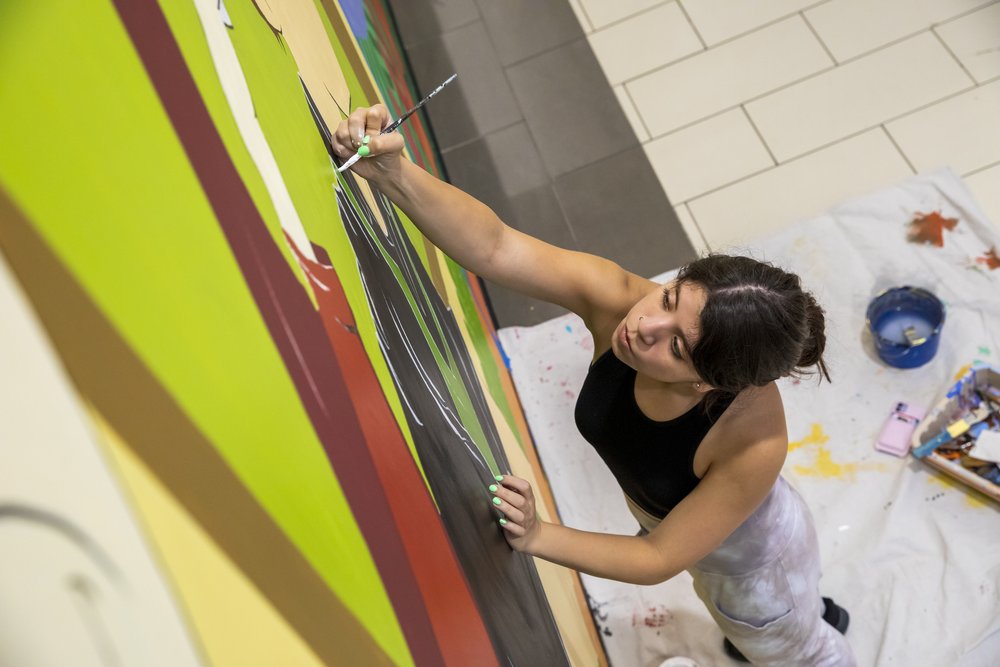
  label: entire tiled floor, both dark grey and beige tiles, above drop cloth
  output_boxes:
[393,0,1000,325]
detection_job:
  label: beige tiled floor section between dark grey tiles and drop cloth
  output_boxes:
[570,0,1000,250]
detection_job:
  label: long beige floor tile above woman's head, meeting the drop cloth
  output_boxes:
[687,128,912,251]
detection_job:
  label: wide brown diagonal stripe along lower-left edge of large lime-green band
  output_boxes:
[0,190,393,665]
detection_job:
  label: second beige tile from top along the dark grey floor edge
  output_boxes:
[588,2,702,85]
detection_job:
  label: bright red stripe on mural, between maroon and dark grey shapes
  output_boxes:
[286,234,497,667]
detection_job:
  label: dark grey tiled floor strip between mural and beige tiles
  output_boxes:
[390,0,695,327]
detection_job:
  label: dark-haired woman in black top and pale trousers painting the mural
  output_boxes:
[333,105,855,666]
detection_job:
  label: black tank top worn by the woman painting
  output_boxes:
[576,350,732,518]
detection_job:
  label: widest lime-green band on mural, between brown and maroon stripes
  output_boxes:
[0,1,412,664]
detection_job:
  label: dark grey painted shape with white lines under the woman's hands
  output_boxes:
[336,172,569,667]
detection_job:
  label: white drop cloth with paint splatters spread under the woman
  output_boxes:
[499,171,1000,667]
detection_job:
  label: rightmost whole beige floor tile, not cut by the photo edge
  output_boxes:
[746,32,972,162]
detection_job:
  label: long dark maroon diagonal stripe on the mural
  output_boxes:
[106,0,443,665]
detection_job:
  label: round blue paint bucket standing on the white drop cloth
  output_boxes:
[867,286,945,368]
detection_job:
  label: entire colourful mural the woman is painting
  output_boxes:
[0,0,604,665]
